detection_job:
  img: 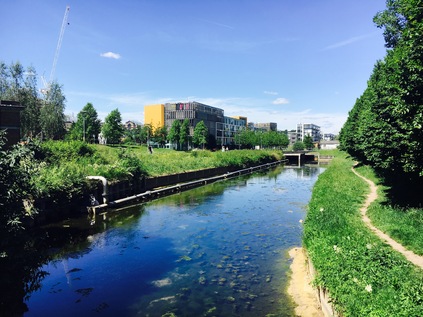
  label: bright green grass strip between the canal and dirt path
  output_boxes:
[304,152,423,316]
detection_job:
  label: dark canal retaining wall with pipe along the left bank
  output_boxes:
[23,159,287,228]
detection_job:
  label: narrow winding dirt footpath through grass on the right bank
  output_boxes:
[351,167,423,269]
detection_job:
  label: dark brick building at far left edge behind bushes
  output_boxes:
[0,100,25,146]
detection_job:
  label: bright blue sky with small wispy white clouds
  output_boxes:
[0,0,386,133]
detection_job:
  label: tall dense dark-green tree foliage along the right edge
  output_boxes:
[340,0,423,204]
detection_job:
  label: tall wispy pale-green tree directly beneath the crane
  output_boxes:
[40,82,66,140]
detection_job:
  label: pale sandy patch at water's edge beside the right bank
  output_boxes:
[288,248,324,317]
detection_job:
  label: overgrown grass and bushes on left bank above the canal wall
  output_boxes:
[0,137,283,241]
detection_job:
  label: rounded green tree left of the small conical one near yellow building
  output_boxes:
[69,103,101,141]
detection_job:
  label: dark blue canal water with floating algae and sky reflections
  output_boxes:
[2,168,320,316]
